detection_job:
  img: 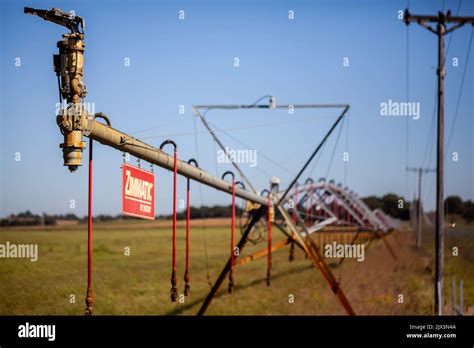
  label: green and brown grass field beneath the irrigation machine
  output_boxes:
[0,221,472,315]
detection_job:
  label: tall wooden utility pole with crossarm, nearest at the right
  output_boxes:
[404,9,474,315]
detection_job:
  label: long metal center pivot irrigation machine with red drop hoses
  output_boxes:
[24,7,399,315]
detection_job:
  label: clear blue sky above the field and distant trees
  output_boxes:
[0,0,474,216]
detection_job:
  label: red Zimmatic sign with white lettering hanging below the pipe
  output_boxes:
[122,163,155,220]
